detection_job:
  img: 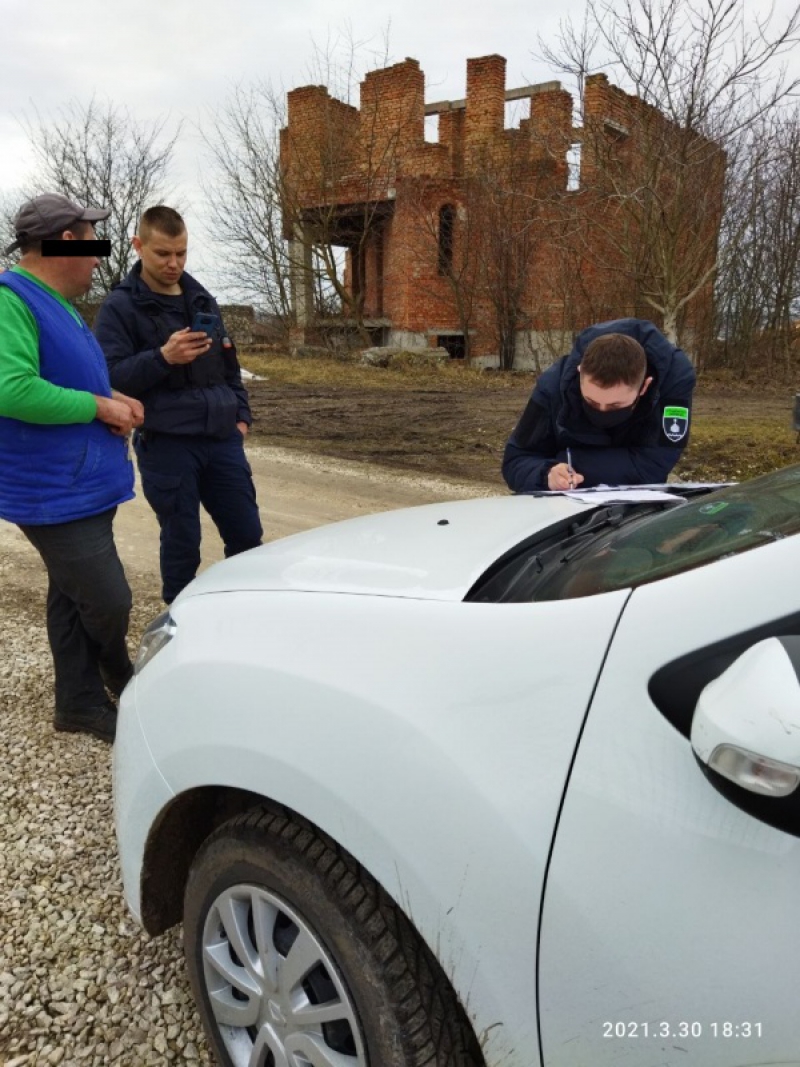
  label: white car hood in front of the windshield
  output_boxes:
[178,496,589,601]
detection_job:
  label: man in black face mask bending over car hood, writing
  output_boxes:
[502,319,695,493]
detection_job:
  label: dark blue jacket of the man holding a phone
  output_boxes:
[94,262,252,439]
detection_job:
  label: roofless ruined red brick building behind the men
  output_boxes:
[281,55,724,366]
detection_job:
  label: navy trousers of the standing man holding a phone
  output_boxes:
[135,430,263,604]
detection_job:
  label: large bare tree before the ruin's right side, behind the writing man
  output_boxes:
[540,0,800,339]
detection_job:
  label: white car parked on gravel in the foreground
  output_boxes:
[114,466,800,1067]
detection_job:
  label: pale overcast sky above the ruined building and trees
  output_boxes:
[0,0,800,300]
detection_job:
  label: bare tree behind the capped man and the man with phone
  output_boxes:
[26,97,180,294]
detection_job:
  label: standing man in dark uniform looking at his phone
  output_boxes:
[94,205,262,604]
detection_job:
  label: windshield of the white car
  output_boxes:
[476,465,800,603]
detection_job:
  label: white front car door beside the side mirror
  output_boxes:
[538,537,800,1067]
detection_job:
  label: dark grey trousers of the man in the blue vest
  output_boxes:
[19,508,131,715]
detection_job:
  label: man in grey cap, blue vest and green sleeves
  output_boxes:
[0,193,144,742]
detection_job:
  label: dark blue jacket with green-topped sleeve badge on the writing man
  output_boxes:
[502,319,695,493]
